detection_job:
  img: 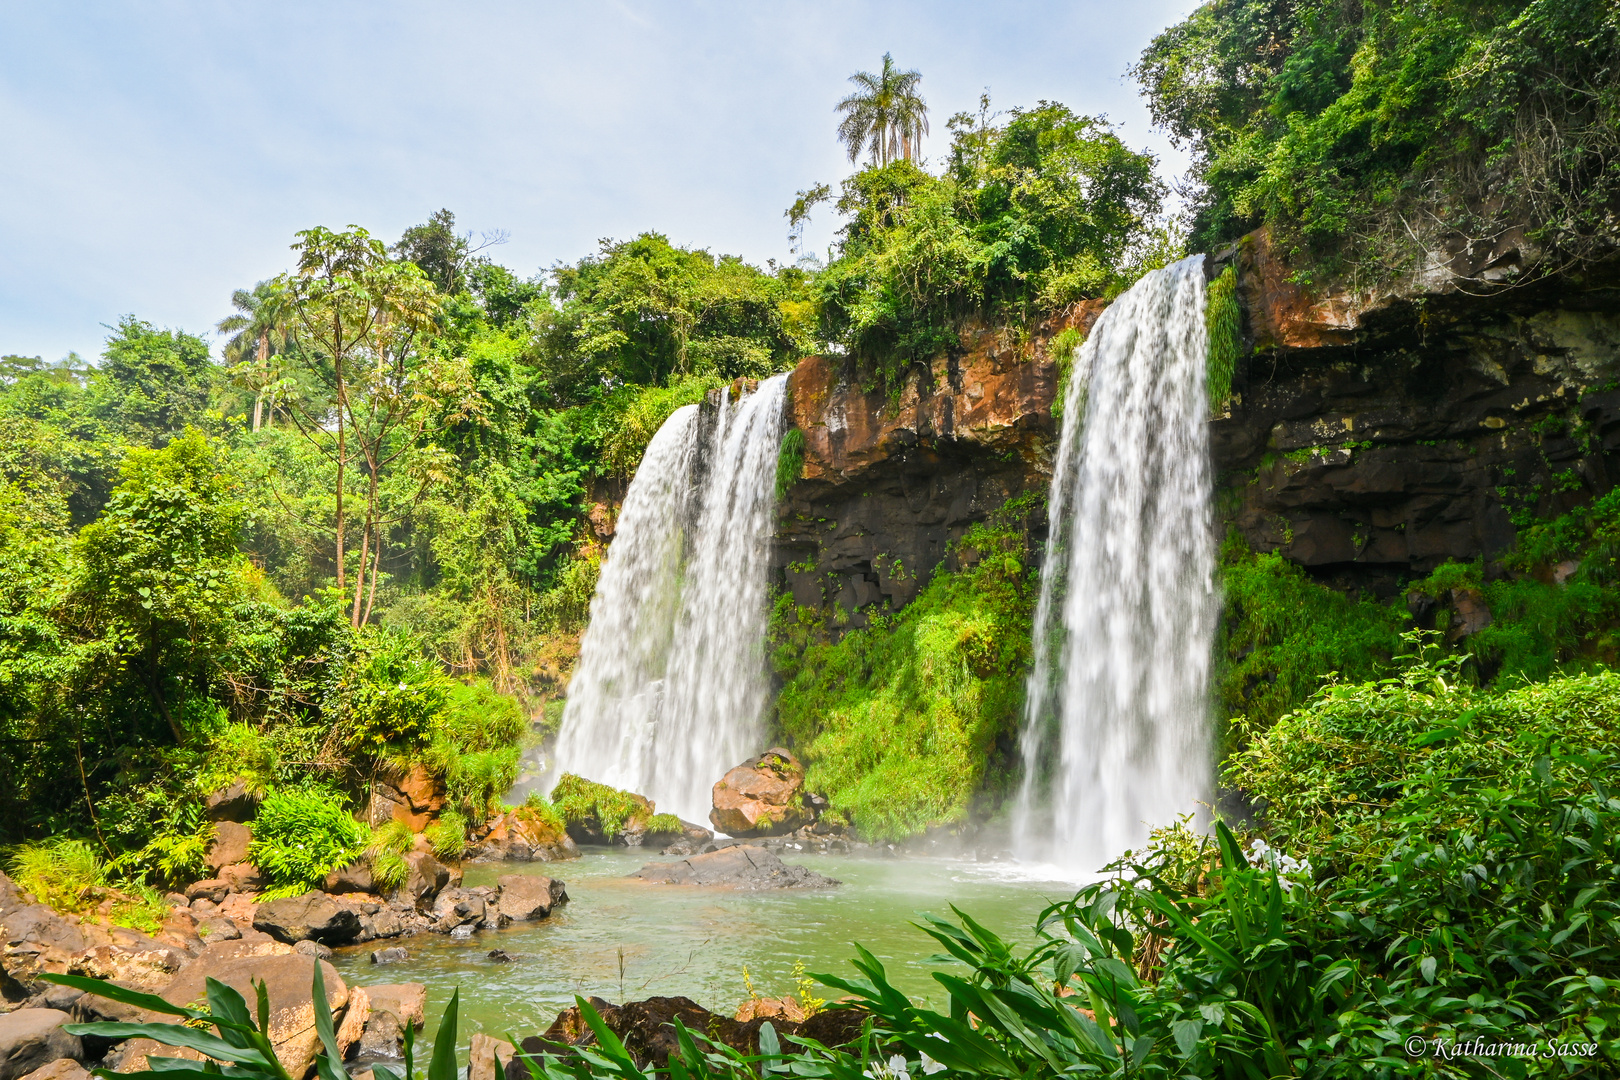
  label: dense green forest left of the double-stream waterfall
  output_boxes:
[0,212,813,889]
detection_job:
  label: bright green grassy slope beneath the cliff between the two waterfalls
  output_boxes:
[773,528,1038,840]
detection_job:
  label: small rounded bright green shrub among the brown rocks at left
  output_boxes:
[248,789,371,899]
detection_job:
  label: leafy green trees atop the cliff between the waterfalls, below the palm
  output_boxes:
[810,102,1162,390]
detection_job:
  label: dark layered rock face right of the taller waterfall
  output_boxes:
[1210,236,1620,594]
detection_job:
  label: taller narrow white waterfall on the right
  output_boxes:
[1014,256,1218,873]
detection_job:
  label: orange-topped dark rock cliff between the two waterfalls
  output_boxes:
[776,303,1103,625]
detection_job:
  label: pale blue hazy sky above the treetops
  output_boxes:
[0,0,1196,359]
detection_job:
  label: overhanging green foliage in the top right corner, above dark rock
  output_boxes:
[1136,0,1620,277]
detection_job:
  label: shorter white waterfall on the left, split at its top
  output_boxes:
[554,376,787,821]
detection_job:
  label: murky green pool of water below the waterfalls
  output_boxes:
[322,848,1074,1062]
